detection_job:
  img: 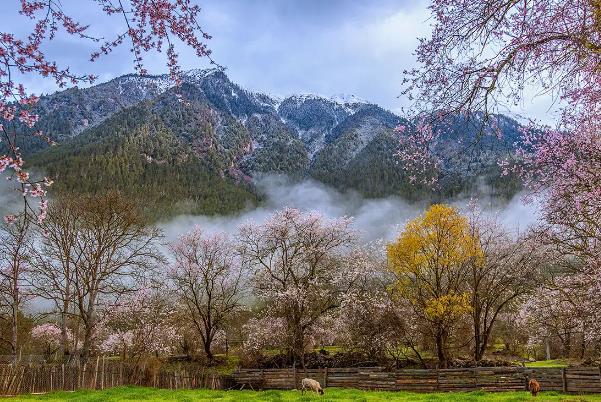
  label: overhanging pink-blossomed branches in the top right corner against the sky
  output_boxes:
[399,0,601,191]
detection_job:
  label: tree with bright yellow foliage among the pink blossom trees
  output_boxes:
[387,204,484,368]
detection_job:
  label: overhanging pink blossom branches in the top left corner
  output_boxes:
[0,0,210,221]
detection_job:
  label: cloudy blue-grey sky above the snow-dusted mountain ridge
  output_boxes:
[0,0,551,122]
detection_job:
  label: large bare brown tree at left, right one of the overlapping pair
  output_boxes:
[73,193,160,361]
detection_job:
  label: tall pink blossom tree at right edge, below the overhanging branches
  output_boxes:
[505,129,601,362]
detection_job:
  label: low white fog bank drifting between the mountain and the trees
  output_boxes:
[159,175,538,241]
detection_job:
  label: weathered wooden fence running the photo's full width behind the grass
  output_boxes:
[0,359,601,395]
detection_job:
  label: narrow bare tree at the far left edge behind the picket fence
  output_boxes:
[0,217,31,359]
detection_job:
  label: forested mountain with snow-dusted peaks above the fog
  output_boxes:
[0,69,519,218]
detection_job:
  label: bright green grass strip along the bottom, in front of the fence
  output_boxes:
[8,387,601,402]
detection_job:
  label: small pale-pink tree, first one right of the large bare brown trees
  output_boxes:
[170,228,242,361]
